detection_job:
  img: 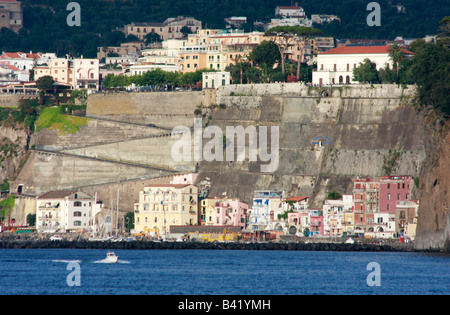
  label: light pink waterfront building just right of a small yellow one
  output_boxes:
[215,199,248,228]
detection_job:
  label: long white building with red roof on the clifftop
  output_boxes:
[312,45,413,85]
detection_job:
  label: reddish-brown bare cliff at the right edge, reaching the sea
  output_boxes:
[415,119,450,252]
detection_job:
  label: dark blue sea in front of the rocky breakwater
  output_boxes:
[0,249,450,295]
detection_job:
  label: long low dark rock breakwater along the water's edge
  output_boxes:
[0,239,428,252]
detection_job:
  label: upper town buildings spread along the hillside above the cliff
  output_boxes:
[0,1,435,101]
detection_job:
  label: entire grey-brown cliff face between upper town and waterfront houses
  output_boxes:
[13,83,450,249]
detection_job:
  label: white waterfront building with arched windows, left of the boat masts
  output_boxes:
[36,190,95,232]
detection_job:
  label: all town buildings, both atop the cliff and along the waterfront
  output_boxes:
[0,1,444,248]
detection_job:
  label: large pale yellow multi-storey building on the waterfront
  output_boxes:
[134,185,198,234]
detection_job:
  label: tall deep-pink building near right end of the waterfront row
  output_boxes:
[379,176,413,214]
